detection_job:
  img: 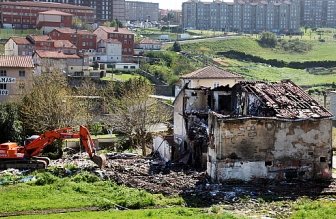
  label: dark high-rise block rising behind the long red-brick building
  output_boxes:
[2,0,125,25]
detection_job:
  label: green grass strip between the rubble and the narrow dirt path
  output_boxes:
[0,173,184,213]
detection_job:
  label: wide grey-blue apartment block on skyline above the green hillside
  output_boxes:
[182,0,300,33]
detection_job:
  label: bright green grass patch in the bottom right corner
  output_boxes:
[290,200,336,219]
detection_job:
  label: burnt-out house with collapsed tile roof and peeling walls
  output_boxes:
[172,80,333,181]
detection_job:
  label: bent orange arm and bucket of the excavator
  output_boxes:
[21,126,106,169]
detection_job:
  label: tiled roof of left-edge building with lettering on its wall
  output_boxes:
[0,55,34,68]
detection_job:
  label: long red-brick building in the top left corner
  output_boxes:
[0,1,94,29]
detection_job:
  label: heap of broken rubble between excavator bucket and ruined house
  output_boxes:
[105,158,207,195]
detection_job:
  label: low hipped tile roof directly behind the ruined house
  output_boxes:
[180,66,244,79]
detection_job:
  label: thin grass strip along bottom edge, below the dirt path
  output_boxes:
[5,207,240,219]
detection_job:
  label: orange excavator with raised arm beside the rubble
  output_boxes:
[0,126,106,169]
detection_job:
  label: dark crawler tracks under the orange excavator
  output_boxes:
[0,158,50,170]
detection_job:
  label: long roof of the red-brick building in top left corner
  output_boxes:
[0,1,95,11]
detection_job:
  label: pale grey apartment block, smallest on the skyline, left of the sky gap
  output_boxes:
[125,1,159,21]
